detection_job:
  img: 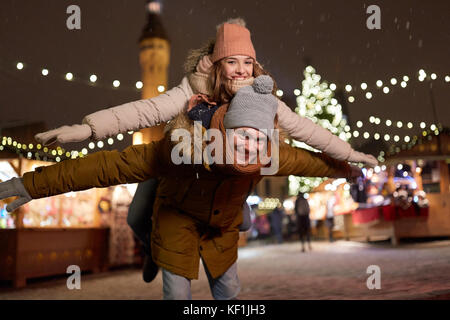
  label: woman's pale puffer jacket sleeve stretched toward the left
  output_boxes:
[83,77,193,140]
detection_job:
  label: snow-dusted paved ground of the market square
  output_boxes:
[0,240,450,300]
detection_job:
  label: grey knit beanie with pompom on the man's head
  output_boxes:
[223,75,278,130]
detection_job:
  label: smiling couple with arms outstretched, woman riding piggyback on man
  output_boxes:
[0,20,376,299]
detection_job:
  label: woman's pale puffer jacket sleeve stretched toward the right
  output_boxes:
[277,100,353,160]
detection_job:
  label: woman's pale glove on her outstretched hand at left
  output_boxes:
[34,124,92,146]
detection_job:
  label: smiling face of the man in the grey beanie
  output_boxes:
[234,127,268,166]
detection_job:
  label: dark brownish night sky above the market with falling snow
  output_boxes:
[0,0,450,154]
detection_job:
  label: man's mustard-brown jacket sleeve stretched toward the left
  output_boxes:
[23,141,166,199]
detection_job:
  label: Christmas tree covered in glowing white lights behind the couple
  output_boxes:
[289,66,351,195]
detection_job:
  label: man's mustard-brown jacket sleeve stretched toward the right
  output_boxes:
[276,143,352,178]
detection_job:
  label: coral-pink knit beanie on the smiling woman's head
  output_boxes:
[211,23,256,63]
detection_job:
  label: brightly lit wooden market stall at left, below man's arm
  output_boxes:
[0,154,109,287]
